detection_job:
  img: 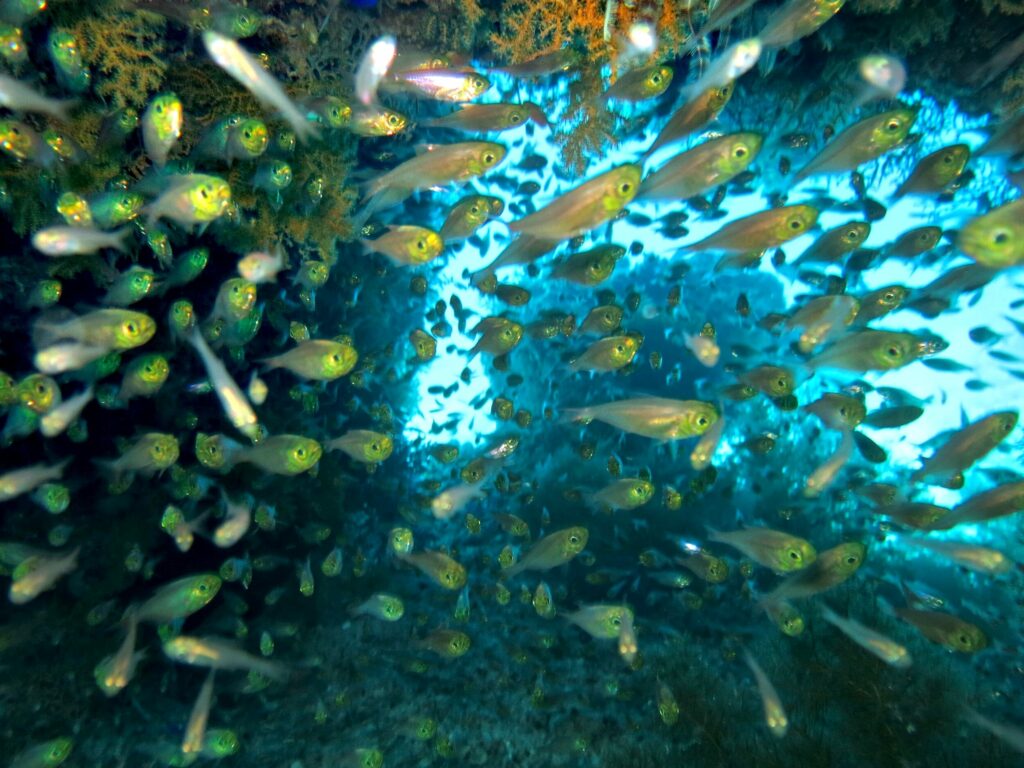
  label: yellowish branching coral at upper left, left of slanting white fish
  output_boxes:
[71,2,167,109]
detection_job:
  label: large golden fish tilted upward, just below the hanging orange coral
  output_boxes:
[509,165,641,241]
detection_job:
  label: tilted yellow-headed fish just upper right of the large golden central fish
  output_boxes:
[637,132,764,200]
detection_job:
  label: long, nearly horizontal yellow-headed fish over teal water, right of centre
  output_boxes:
[564,397,719,440]
